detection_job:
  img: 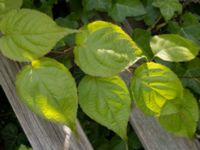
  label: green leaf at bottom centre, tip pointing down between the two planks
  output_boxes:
[78,76,131,139]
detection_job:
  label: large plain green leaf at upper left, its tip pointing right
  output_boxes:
[0,9,75,61]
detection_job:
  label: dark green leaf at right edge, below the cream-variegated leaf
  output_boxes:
[182,58,200,95]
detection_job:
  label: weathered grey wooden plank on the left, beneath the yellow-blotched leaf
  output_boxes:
[0,54,93,150]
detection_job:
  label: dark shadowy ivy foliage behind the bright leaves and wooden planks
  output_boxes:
[0,0,200,150]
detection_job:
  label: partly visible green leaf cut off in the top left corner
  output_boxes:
[0,0,23,17]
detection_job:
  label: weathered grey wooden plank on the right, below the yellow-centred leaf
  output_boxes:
[121,71,200,150]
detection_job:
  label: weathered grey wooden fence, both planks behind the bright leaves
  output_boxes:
[0,54,200,150]
